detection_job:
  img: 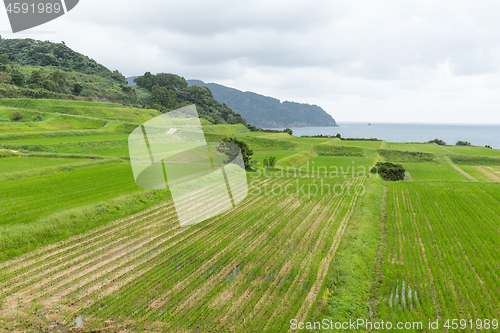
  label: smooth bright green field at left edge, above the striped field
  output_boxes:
[0,163,142,225]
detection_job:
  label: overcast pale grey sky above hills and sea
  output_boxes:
[0,0,500,124]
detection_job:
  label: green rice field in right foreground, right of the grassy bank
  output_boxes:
[380,183,500,332]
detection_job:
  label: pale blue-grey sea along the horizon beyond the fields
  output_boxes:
[278,123,500,149]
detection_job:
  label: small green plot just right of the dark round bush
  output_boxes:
[403,163,467,182]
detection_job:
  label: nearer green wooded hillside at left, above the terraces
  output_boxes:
[0,36,246,124]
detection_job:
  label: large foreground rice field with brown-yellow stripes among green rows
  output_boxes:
[0,178,364,332]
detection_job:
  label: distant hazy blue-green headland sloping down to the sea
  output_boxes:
[187,80,337,127]
